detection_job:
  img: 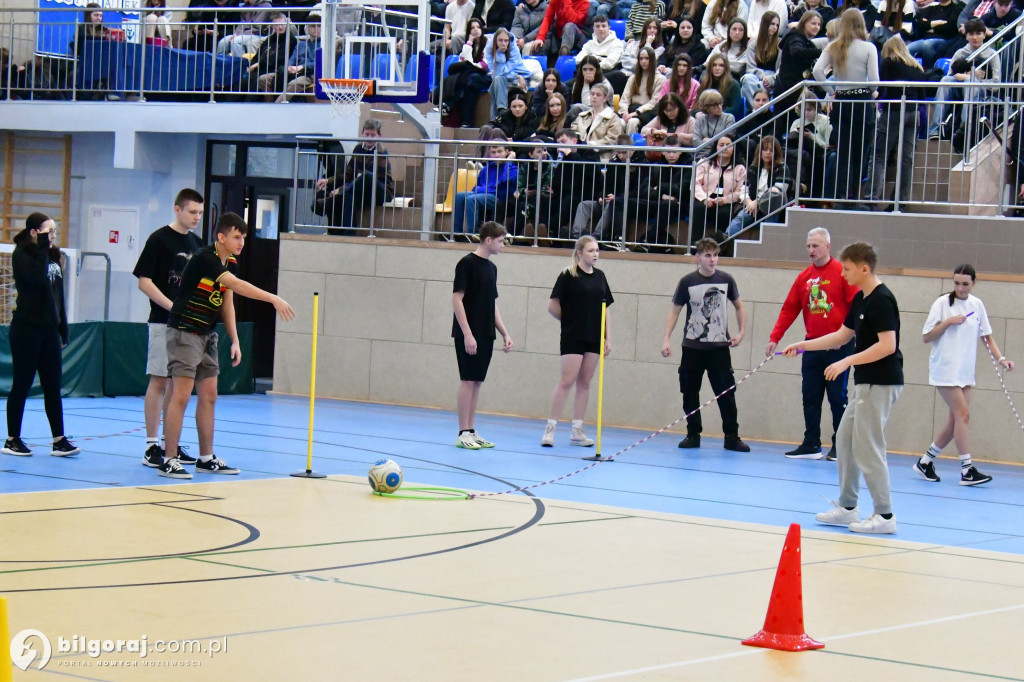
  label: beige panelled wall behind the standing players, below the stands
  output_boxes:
[273,235,1024,462]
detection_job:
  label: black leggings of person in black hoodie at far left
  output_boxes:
[7,318,65,438]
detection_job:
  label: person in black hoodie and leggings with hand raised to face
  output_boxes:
[0,213,82,457]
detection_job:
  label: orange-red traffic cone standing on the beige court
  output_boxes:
[743,523,825,651]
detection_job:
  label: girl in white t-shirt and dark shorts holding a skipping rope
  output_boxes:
[913,265,1014,485]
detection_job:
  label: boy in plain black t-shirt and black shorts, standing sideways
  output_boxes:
[452,220,513,450]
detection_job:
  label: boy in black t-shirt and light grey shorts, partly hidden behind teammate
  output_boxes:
[132,188,203,468]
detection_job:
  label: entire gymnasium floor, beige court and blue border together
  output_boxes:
[0,396,1024,682]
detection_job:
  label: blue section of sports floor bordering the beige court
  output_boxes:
[8,395,1024,554]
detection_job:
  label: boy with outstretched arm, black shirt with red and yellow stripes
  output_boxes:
[159,213,295,478]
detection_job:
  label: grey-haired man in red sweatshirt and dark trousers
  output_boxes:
[765,227,859,460]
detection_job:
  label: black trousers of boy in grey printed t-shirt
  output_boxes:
[679,346,739,437]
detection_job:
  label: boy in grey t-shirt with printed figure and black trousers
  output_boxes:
[662,239,751,453]
